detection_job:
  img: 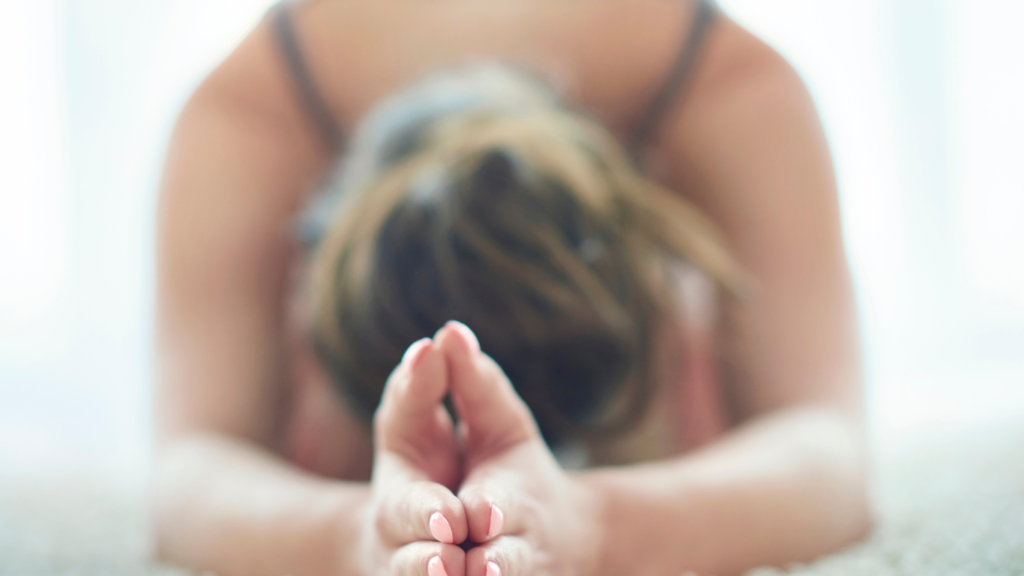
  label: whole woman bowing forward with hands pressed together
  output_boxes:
[155,0,868,576]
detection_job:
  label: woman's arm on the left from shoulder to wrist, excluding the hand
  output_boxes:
[154,20,358,575]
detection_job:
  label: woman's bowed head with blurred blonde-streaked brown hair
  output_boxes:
[310,63,738,441]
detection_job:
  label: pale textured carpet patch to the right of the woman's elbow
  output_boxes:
[748,416,1024,576]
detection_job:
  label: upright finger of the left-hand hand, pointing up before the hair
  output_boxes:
[374,338,452,450]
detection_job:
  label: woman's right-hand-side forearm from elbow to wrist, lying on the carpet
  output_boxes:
[578,409,870,576]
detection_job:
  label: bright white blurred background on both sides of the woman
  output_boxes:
[0,0,1024,472]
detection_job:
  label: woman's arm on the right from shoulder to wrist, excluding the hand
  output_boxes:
[580,20,870,576]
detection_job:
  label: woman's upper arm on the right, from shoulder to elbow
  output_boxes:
[657,18,862,421]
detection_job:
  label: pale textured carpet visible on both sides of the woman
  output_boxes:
[0,416,1024,576]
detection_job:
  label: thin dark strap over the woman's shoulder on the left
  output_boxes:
[269,0,342,149]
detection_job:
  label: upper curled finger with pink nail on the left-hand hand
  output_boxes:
[375,481,468,546]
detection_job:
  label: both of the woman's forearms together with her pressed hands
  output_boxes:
[155,313,869,576]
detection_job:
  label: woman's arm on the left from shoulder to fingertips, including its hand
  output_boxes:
[153,15,467,576]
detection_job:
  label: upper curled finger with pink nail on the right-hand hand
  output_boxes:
[459,457,530,543]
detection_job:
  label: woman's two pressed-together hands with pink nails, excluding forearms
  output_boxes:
[360,322,601,576]
